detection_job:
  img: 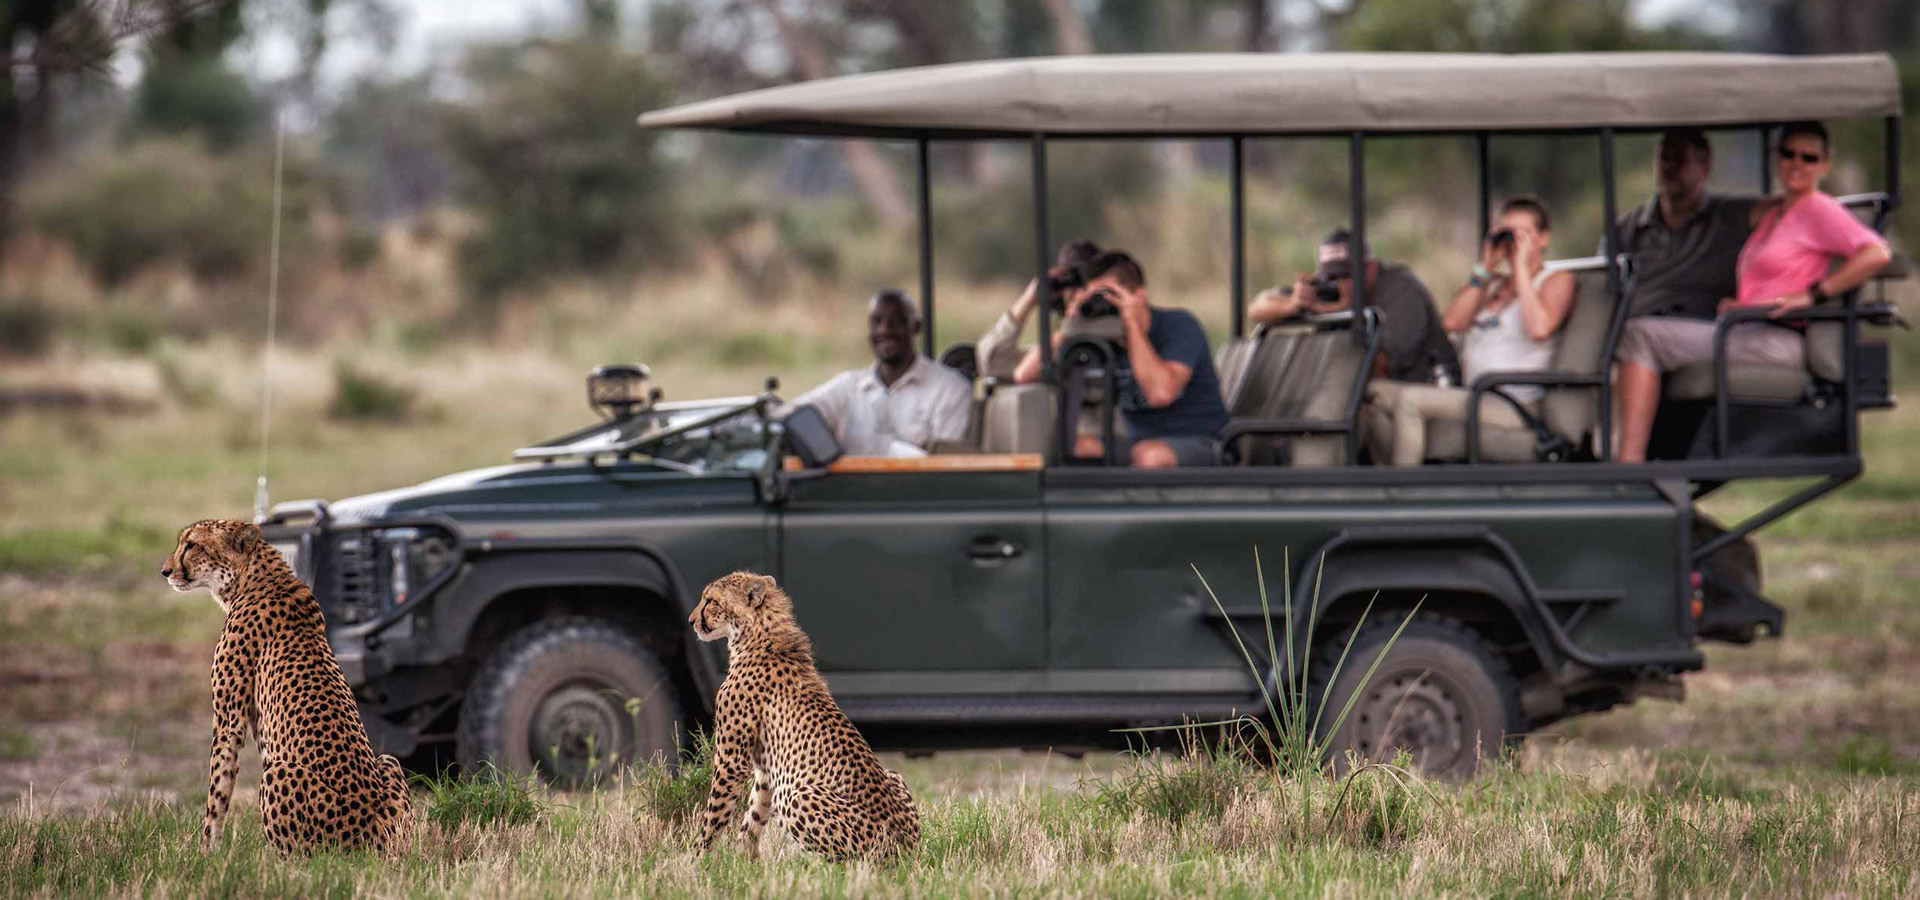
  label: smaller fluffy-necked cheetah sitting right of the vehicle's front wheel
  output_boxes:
[687,572,920,860]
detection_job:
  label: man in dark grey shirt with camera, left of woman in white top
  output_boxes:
[1246,228,1459,386]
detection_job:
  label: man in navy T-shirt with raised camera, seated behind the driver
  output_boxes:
[1014,251,1227,468]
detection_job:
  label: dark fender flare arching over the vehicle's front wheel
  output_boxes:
[436,547,726,693]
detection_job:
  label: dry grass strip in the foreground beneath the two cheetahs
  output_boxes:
[0,748,1920,896]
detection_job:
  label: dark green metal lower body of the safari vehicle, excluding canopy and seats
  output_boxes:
[255,391,1701,773]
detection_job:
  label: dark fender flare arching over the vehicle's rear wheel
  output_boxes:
[1294,530,1563,672]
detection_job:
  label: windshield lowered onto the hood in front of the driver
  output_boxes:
[515,397,768,474]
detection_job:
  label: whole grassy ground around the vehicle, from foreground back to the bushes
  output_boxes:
[0,291,1920,896]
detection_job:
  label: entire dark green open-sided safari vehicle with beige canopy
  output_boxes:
[263,54,1901,783]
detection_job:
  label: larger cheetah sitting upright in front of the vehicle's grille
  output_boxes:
[159,520,413,854]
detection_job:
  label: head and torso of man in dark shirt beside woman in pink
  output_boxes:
[1603,129,1755,319]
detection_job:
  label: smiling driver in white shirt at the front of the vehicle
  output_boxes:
[793,290,973,457]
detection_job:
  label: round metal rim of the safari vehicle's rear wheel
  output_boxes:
[1354,668,1475,771]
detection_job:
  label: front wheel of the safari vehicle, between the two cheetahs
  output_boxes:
[459,618,685,789]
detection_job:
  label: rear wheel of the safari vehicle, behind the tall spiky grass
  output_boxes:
[1308,612,1526,781]
